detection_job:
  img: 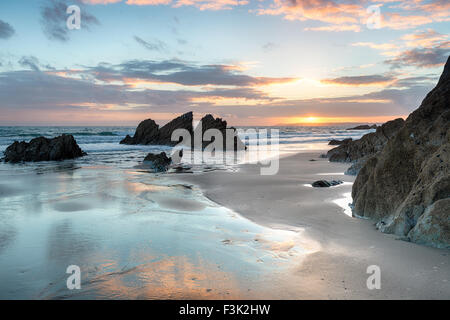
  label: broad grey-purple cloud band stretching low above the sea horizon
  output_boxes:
[0,57,436,124]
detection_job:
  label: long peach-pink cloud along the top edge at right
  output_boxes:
[255,0,450,32]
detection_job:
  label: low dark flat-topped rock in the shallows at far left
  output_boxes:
[5,134,86,163]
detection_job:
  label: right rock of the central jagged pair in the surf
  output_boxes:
[194,114,246,151]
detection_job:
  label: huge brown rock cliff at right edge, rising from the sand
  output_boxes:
[352,59,450,248]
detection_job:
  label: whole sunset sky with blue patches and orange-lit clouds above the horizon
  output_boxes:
[0,0,450,126]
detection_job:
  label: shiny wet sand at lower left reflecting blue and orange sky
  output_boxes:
[0,167,316,299]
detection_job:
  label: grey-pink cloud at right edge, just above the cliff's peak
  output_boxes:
[384,41,450,68]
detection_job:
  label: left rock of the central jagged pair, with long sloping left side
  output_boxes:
[120,112,193,146]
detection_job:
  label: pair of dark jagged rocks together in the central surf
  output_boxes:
[120,112,246,150]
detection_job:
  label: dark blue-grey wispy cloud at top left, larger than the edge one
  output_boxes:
[41,0,99,42]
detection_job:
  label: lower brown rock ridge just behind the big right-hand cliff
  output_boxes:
[327,118,404,162]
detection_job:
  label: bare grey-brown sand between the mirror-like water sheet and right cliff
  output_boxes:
[173,152,450,299]
